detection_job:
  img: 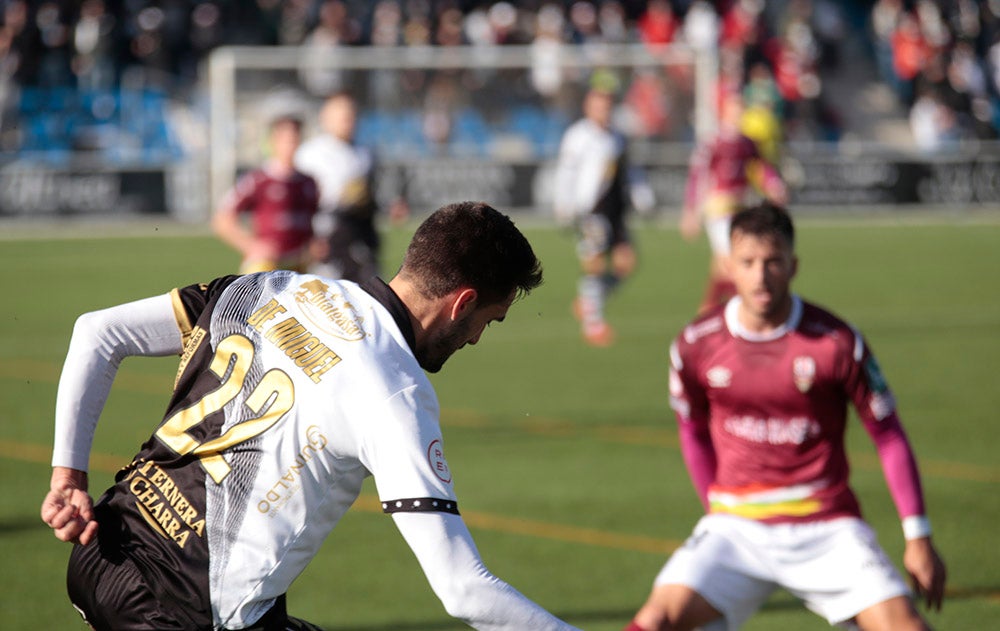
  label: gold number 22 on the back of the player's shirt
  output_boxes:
[156,335,295,484]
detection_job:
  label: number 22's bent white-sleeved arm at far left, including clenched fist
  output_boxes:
[41,294,182,544]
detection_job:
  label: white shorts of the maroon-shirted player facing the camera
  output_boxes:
[654,515,910,629]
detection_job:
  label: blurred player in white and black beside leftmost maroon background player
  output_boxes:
[295,92,409,282]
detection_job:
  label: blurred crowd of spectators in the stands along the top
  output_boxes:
[0,0,1000,160]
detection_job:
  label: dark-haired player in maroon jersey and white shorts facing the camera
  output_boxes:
[627,202,945,631]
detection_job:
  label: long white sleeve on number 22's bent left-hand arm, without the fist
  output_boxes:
[52,294,183,471]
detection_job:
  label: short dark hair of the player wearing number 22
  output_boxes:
[399,202,542,305]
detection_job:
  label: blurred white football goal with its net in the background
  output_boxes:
[205,43,718,217]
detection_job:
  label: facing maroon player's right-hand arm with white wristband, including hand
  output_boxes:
[848,333,947,609]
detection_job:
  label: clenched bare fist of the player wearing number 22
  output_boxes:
[41,467,97,545]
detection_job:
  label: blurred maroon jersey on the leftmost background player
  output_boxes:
[223,168,319,257]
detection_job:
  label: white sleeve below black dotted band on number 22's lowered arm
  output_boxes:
[392,513,576,631]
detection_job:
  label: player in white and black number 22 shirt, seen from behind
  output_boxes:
[41,202,573,631]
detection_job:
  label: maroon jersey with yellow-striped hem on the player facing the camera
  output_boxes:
[670,297,896,523]
